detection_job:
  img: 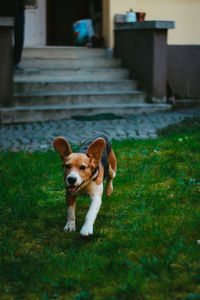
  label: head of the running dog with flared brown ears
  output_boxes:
[54,137,106,194]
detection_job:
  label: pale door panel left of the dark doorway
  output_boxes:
[24,0,46,47]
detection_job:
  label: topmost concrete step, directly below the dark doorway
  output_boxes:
[23,47,108,59]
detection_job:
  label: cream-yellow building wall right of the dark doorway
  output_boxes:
[103,0,200,48]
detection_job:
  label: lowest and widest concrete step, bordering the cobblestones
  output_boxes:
[0,103,171,124]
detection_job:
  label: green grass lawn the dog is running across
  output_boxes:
[0,119,200,300]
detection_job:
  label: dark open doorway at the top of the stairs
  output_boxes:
[47,0,102,46]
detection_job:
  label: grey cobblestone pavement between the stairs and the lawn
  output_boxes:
[0,109,200,151]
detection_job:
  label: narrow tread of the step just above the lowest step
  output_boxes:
[14,90,144,97]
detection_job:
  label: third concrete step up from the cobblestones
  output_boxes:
[14,78,137,93]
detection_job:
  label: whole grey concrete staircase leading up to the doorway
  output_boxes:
[1,47,170,123]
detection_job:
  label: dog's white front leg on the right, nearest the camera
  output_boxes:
[80,183,103,236]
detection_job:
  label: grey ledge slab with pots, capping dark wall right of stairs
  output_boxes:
[114,21,175,30]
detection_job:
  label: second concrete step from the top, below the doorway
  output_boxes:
[21,57,121,69]
